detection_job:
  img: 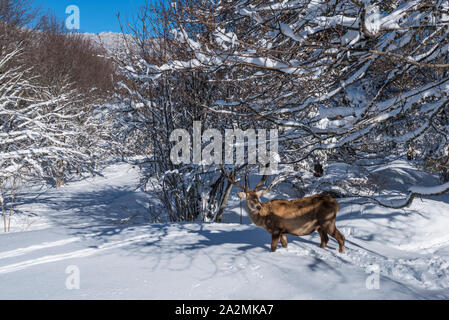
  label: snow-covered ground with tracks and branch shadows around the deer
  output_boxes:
[0,163,449,299]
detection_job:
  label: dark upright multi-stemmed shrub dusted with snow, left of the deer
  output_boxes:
[109,38,236,222]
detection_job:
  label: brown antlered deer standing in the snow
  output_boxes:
[221,166,345,253]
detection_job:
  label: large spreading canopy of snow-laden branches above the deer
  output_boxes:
[114,0,449,219]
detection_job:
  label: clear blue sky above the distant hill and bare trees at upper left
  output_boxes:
[34,0,149,33]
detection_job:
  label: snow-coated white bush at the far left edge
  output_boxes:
[0,47,105,229]
